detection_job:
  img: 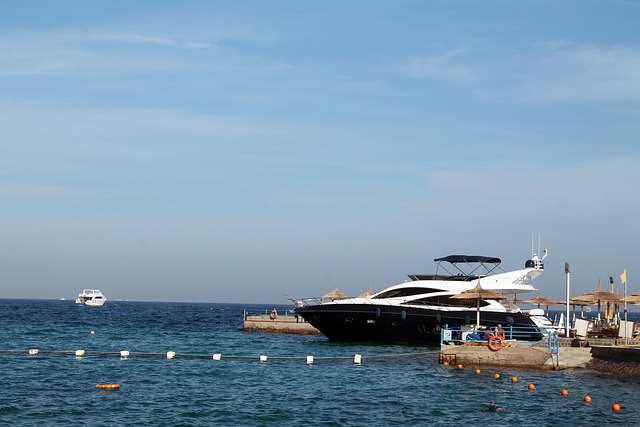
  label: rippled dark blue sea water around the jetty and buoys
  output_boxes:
[0,299,640,426]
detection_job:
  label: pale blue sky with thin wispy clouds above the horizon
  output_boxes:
[0,0,640,304]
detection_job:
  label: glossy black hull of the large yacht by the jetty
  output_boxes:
[296,303,542,343]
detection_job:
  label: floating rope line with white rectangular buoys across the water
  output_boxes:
[0,348,433,366]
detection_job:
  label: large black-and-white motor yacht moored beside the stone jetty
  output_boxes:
[296,249,546,342]
